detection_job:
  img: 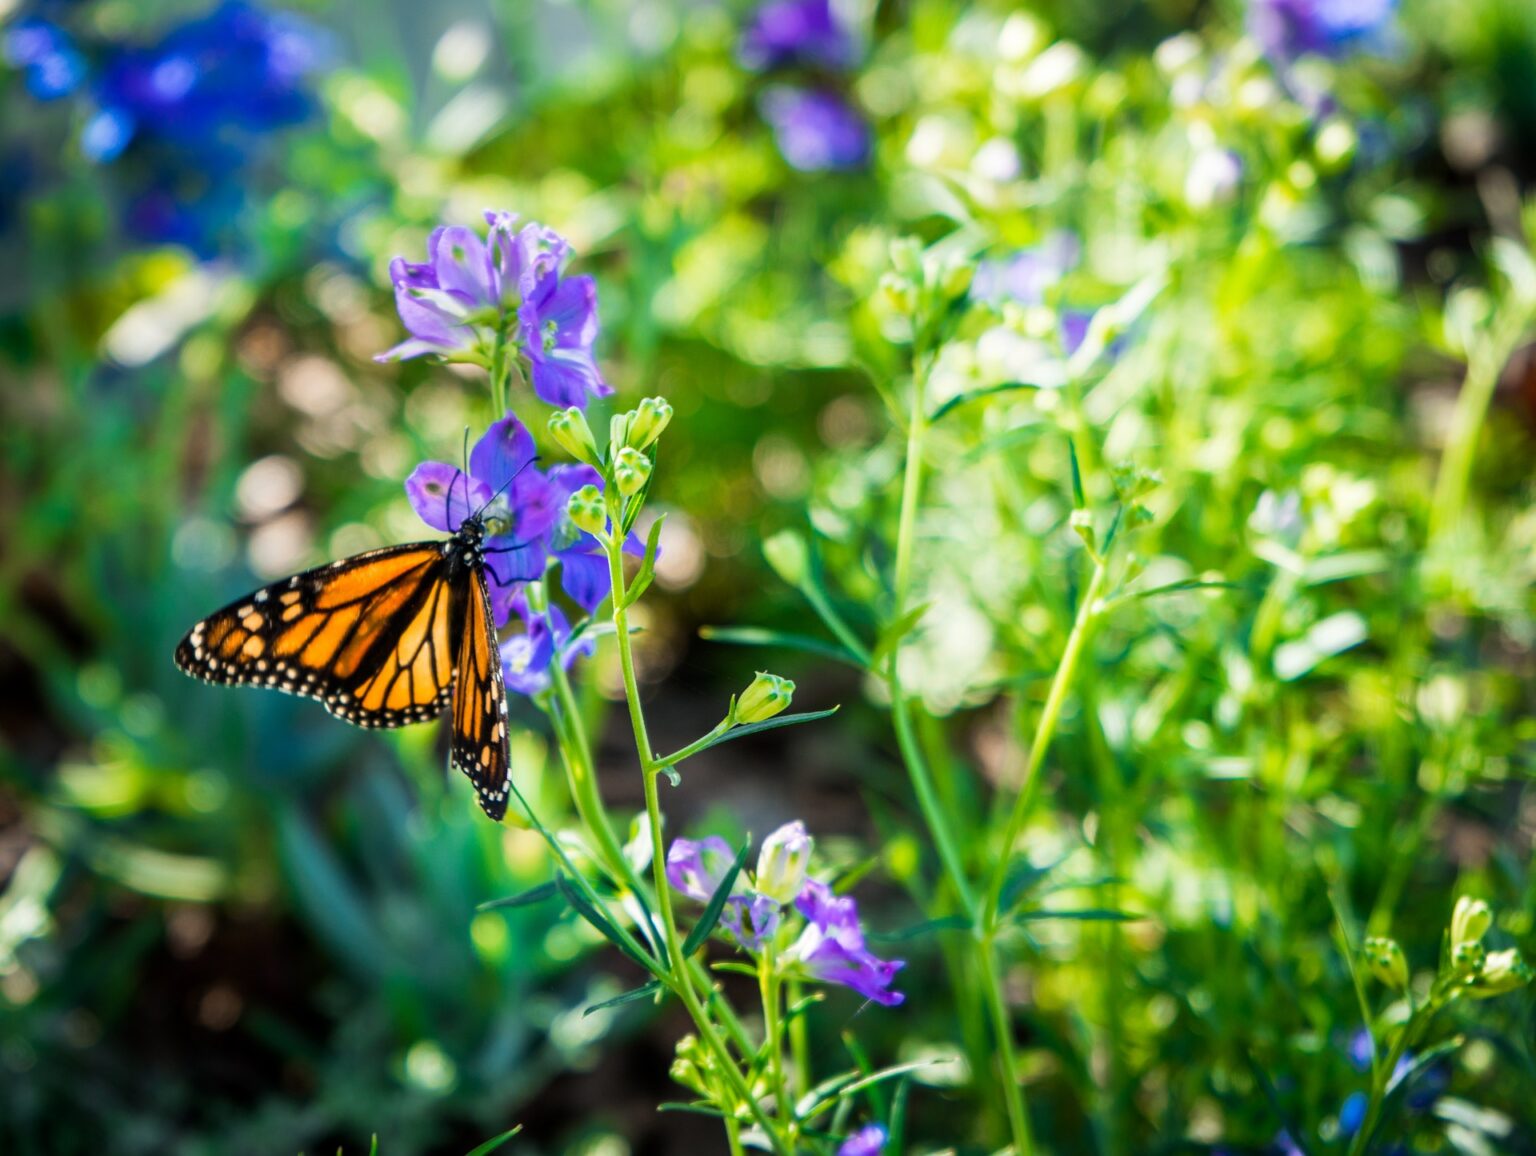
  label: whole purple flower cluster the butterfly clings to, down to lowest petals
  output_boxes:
[406,416,644,644]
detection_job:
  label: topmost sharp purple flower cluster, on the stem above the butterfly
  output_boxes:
[378,212,613,407]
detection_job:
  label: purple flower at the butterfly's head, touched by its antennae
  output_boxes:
[406,416,559,626]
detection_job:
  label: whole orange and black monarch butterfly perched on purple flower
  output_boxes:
[175,478,510,821]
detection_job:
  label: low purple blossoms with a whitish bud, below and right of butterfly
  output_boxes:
[667,823,906,1000]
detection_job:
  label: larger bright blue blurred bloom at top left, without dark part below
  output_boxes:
[83,0,323,161]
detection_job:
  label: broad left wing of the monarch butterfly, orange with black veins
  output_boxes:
[175,542,455,728]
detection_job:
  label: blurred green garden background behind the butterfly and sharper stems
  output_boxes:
[9,0,1536,1156]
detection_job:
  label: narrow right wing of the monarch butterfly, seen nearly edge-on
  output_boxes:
[449,566,511,821]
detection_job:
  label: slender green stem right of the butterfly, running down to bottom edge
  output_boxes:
[604,491,790,1156]
